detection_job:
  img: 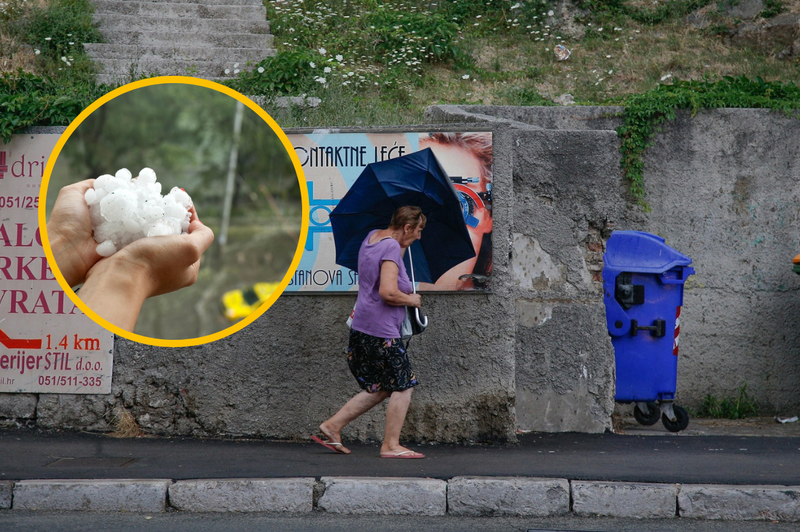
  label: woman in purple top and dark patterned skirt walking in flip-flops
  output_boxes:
[311,206,426,458]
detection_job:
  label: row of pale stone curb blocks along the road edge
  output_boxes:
[0,477,800,522]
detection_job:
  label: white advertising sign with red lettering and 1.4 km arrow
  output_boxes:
[0,134,114,394]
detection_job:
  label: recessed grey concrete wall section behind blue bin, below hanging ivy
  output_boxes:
[640,109,800,415]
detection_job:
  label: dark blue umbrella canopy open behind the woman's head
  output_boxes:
[330,148,475,283]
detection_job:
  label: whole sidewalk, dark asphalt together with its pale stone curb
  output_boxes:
[0,420,800,521]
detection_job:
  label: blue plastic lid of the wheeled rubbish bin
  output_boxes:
[603,231,692,273]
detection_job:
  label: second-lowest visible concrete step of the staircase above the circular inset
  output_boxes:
[84,43,275,64]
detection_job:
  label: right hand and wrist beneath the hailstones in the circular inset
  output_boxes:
[80,208,214,331]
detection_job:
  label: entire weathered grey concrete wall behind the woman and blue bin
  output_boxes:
[0,106,800,442]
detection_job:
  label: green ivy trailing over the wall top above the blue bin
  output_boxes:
[617,76,800,209]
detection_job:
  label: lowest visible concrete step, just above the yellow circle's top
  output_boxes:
[92,57,252,79]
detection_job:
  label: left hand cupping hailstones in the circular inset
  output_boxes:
[47,179,102,286]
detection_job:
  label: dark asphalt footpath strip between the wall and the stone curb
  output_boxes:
[0,429,800,485]
